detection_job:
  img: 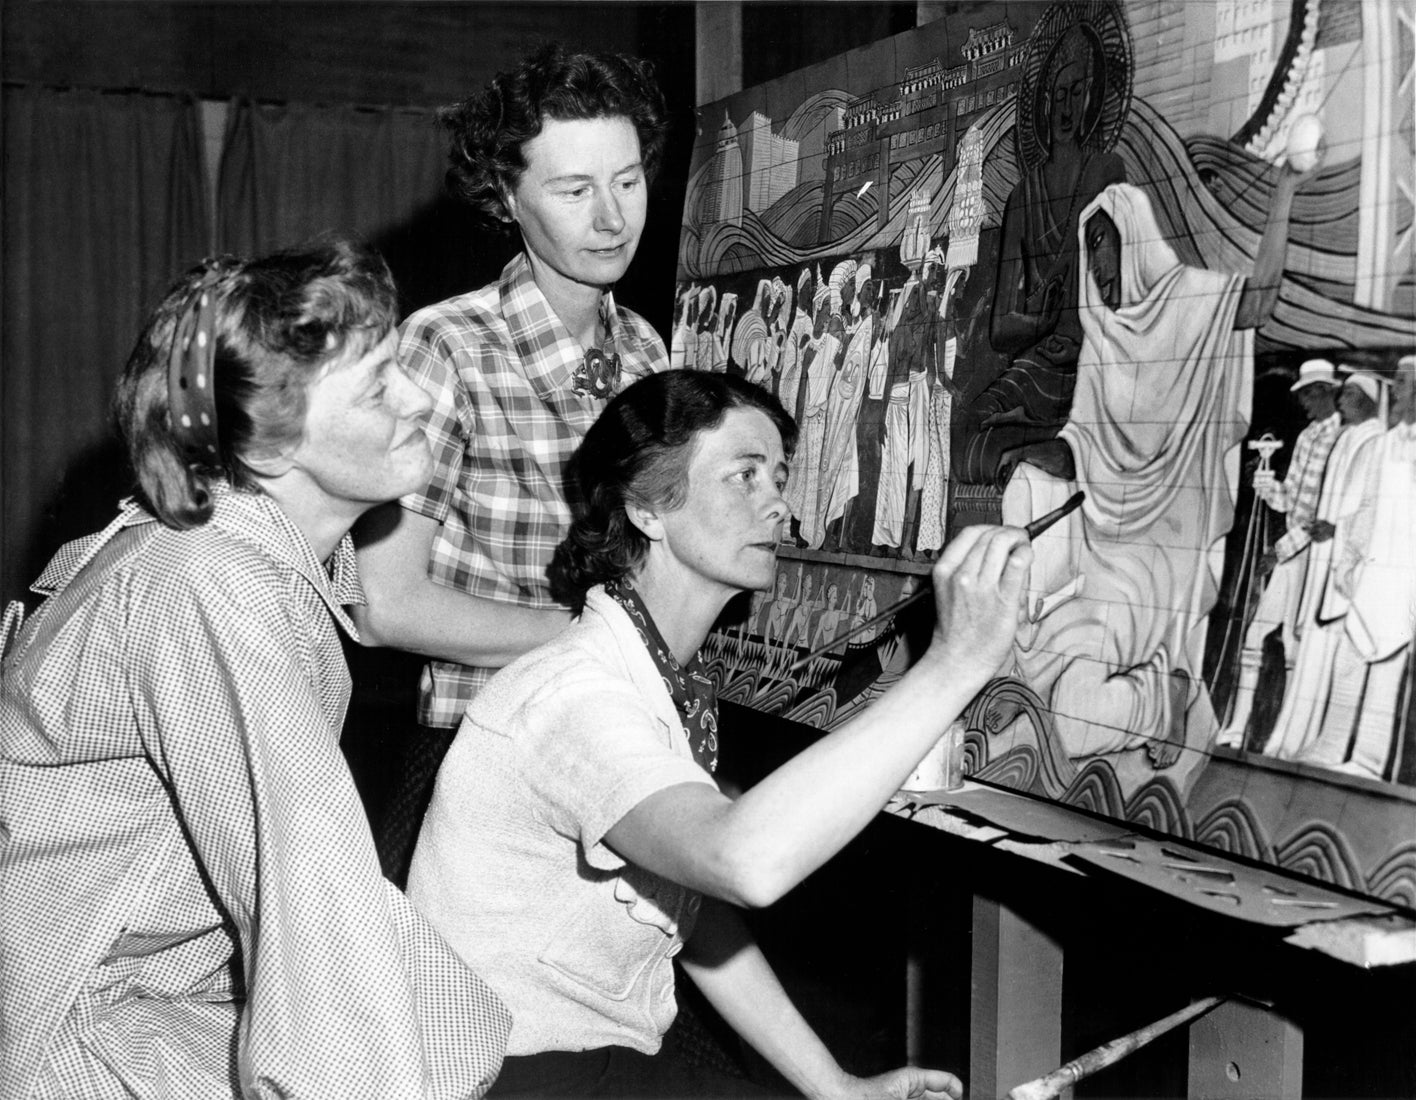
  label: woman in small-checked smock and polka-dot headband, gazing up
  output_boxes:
[0,244,510,1100]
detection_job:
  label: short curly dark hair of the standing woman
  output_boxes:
[438,42,668,227]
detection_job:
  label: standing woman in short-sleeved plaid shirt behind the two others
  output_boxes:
[348,45,668,881]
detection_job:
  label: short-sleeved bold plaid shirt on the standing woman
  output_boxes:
[399,253,668,726]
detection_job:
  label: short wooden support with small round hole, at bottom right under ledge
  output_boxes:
[1187,1001,1303,1100]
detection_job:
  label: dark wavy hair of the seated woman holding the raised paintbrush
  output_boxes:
[548,371,797,614]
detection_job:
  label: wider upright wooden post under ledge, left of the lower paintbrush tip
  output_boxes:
[967,895,1062,1100]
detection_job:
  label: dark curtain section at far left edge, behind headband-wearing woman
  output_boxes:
[0,88,207,599]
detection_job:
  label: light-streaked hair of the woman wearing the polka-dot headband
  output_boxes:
[113,238,398,529]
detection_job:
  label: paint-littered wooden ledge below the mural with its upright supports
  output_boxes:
[886,781,1416,1100]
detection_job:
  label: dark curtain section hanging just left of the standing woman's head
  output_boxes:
[217,101,510,311]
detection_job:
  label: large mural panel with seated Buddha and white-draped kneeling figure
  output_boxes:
[673,0,1416,907]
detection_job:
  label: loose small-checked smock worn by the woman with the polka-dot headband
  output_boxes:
[0,488,510,1100]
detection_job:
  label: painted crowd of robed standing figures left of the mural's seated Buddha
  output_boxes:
[673,249,956,558]
